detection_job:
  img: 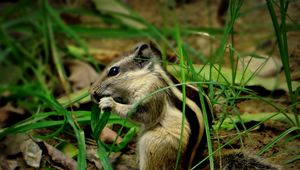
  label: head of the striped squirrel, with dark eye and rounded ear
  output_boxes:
[89,43,161,104]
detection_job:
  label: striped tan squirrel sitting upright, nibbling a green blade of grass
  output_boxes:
[90,44,210,170]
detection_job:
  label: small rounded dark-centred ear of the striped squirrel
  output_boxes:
[134,43,162,67]
